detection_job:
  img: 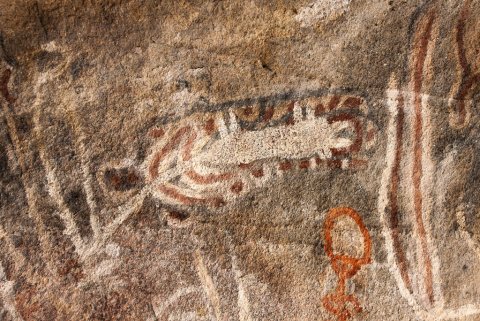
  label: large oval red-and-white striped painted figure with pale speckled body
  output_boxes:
[144,93,376,206]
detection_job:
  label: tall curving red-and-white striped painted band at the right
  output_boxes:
[378,7,480,321]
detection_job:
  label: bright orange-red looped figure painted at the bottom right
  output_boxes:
[322,207,372,321]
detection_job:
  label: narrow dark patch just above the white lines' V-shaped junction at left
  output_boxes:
[65,187,92,237]
